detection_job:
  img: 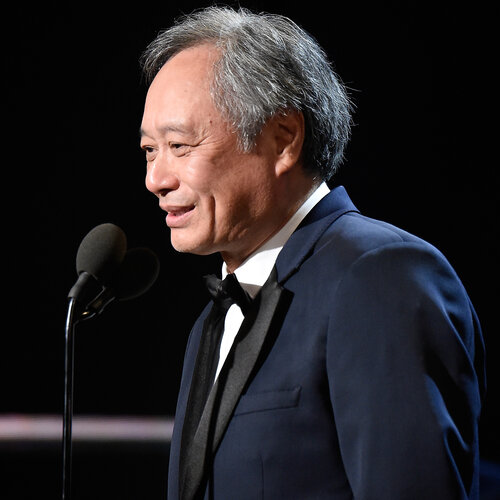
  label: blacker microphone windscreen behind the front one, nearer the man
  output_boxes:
[110,247,160,300]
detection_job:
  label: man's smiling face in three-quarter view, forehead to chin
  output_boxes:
[141,45,282,263]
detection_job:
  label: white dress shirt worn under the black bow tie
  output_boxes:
[215,182,330,379]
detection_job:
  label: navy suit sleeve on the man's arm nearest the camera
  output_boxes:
[327,243,484,500]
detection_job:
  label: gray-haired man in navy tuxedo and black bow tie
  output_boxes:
[141,7,484,500]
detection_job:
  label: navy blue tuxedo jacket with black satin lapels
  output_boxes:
[168,187,484,500]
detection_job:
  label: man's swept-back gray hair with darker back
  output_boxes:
[141,7,351,180]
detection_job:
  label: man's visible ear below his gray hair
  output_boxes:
[272,110,305,176]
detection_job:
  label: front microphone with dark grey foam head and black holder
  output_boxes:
[68,223,127,309]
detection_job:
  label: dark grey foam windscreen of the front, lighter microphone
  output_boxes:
[76,223,127,282]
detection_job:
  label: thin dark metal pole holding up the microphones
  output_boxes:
[62,297,77,500]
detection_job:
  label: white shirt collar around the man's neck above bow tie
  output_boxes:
[222,182,330,298]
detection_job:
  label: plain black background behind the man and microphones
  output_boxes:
[0,0,500,499]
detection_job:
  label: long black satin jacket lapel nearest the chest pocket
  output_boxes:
[180,269,283,500]
